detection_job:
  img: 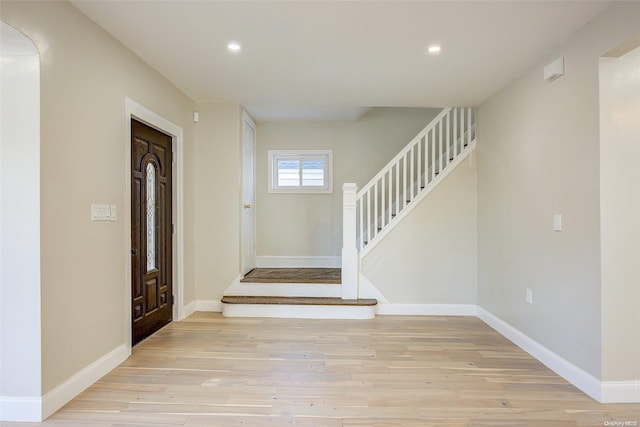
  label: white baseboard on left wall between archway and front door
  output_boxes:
[42,344,130,419]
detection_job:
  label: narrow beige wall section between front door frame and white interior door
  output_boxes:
[194,104,242,301]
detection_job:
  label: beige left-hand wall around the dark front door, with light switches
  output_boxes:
[0,1,195,394]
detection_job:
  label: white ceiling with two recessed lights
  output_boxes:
[72,0,611,120]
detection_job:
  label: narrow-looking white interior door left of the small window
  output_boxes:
[241,113,256,273]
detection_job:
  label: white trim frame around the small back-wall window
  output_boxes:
[267,150,333,194]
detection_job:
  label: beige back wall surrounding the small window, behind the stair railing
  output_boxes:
[256,108,440,256]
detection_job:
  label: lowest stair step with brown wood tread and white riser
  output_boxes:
[222,296,378,319]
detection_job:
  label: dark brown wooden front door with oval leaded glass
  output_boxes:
[131,119,173,345]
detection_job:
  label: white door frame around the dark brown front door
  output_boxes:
[122,98,185,354]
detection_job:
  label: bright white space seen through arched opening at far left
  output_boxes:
[0,22,42,421]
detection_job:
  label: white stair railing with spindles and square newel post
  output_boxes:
[342,108,476,299]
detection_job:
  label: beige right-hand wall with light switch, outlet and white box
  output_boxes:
[478,2,640,378]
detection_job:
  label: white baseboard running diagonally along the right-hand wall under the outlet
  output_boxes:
[478,307,602,402]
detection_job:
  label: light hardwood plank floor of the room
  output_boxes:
[3,313,640,427]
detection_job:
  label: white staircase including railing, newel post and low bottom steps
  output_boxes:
[222,108,476,319]
